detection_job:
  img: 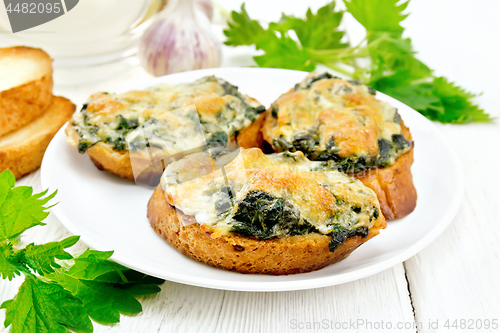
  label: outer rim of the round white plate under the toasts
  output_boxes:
[40,67,465,292]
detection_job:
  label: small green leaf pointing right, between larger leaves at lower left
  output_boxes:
[19,236,80,275]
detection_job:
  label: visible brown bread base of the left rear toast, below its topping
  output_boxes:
[65,115,264,185]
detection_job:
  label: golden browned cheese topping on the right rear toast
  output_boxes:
[268,74,411,164]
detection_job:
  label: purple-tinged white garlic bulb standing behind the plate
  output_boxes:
[139,0,222,76]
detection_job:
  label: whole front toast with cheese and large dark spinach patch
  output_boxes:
[148,148,386,275]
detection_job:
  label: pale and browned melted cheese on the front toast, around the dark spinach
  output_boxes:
[161,148,381,237]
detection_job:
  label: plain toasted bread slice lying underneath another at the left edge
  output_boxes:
[0,96,76,179]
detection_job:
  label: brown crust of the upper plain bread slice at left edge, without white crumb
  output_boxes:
[0,47,53,137]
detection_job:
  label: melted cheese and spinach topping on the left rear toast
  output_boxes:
[72,76,264,150]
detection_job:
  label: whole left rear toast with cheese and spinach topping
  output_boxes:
[66,76,265,183]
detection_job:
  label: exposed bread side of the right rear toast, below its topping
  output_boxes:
[352,122,417,221]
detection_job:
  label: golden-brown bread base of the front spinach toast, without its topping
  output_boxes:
[148,187,386,275]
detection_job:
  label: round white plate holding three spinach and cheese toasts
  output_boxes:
[41,68,464,291]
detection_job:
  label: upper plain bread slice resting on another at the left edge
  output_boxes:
[0,47,53,137]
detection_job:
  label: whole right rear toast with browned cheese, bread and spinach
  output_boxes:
[262,73,417,220]
